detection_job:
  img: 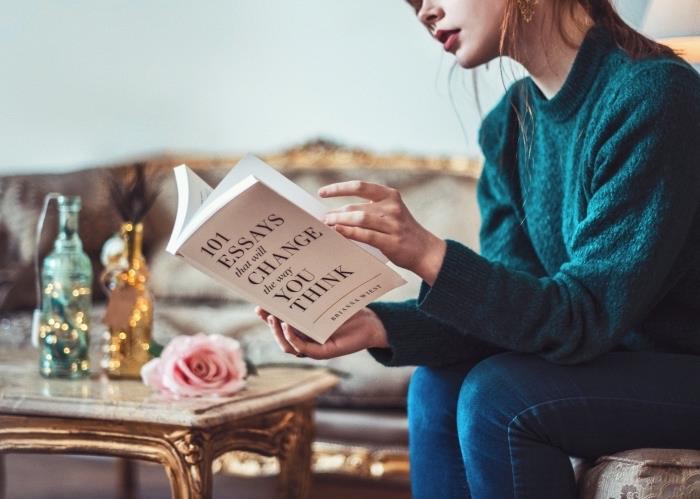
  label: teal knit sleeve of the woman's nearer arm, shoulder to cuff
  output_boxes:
[416,64,700,363]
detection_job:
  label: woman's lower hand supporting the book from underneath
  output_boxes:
[255,307,388,359]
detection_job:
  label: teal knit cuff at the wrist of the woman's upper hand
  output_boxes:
[416,239,492,333]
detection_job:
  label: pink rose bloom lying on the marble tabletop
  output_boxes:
[141,333,246,397]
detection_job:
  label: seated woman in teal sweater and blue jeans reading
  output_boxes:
[257,0,700,499]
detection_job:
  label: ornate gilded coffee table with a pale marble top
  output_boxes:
[0,350,338,499]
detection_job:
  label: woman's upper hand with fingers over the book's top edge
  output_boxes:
[318,180,447,286]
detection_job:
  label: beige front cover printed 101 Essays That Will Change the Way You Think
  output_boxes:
[180,181,405,343]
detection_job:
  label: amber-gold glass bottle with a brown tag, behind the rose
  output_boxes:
[102,222,153,378]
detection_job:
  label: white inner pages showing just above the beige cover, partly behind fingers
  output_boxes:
[203,154,389,263]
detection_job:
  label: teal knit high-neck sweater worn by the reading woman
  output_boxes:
[369,26,700,365]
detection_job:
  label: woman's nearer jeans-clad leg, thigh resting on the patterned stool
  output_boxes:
[457,352,700,499]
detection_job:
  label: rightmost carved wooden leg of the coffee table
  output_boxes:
[277,405,314,499]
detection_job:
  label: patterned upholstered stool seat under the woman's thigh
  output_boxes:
[579,449,700,499]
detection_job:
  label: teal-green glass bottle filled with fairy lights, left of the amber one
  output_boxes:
[39,196,92,378]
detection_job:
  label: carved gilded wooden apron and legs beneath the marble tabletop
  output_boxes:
[0,402,314,499]
